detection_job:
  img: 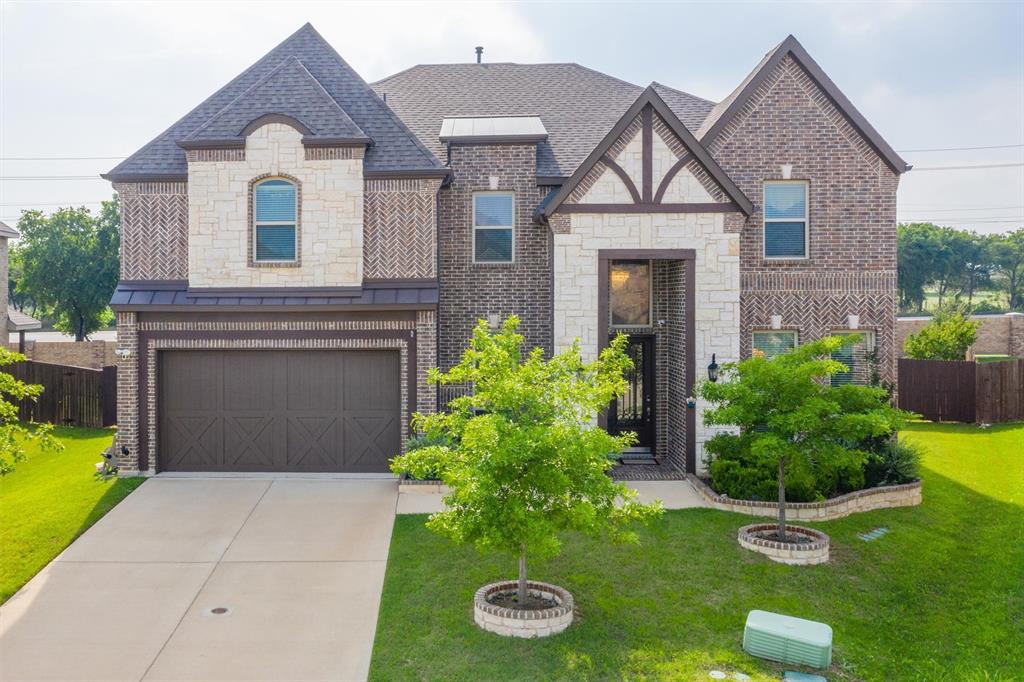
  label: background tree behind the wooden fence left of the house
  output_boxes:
[17,196,120,341]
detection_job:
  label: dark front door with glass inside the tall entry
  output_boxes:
[608,336,654,453]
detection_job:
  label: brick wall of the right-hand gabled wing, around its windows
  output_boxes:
[709,56,899,383]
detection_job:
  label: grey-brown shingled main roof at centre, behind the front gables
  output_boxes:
[373,63,715,177]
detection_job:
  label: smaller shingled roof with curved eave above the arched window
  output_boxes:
[178,55,370,148]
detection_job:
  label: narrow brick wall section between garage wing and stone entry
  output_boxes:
[438,144,553,369]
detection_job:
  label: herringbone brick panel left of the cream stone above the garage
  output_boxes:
[114,182,188,280]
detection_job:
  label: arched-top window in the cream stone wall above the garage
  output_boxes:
[253,178,298,263]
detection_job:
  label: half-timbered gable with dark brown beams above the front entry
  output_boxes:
[535,87,754,220]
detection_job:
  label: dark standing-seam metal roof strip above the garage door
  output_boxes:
[111,283,437,310]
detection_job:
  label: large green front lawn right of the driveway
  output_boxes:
[371,423,1024,680]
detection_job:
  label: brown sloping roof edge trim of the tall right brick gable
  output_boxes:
[697,35,910,173]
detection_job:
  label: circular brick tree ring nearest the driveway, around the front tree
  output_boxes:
[473,581,574,639]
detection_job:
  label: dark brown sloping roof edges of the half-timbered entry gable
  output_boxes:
[535,83,754,218]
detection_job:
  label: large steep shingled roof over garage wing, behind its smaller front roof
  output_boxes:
[103,24,446,182]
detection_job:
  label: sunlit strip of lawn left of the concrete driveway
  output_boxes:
[0,428,145,603]
